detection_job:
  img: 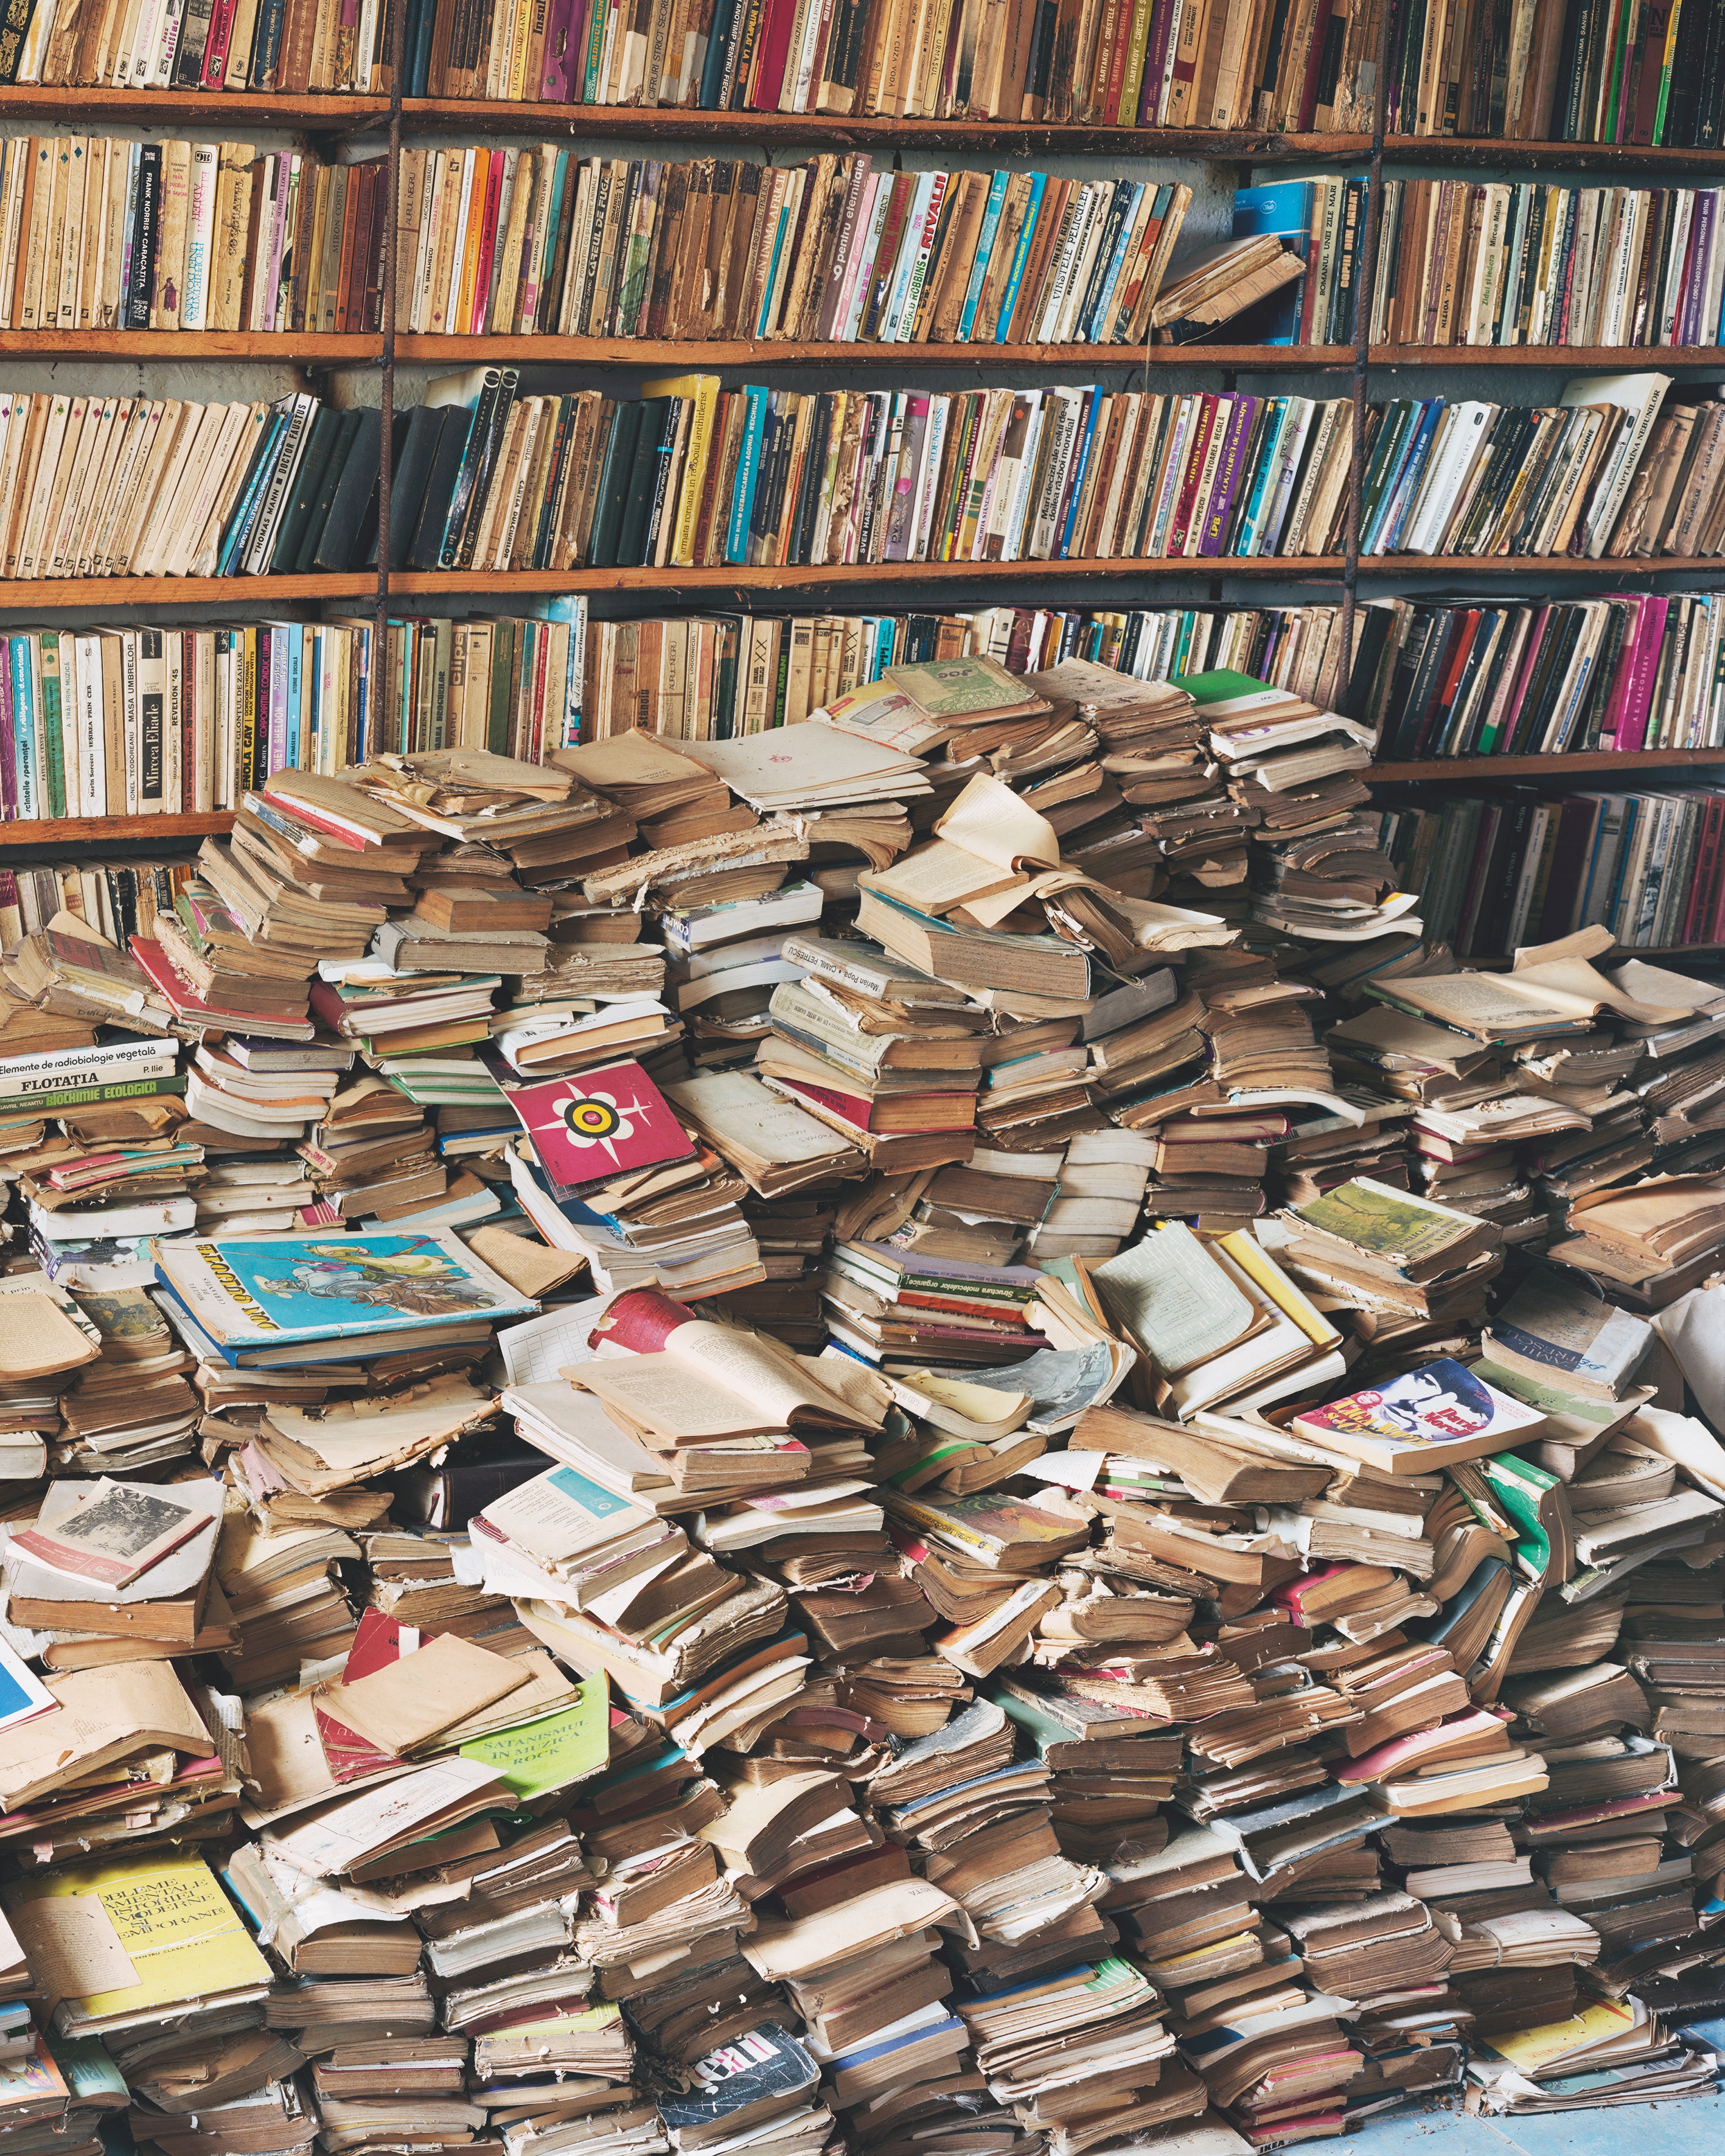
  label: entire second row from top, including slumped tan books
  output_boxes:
[23,134,1725,349]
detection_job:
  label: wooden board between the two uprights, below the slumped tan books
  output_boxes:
[395,334,1354,375]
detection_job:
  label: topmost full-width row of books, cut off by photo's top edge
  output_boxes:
[0,0,1725,148]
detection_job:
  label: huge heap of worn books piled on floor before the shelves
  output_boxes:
[0,655,1725,2156]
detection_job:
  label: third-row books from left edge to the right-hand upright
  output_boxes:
[0,369,1350,580]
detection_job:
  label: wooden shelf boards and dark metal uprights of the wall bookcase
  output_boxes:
[0,27,1725,851]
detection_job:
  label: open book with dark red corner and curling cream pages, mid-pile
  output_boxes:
[567,1287,877,1446]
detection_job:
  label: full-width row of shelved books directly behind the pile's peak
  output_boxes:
[0,593,1725,823]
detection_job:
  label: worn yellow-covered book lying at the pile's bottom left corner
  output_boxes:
[7,1854,270,2036]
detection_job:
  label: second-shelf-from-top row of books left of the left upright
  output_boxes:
[0,136,388,332]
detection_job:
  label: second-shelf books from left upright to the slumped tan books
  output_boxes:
[392,142,1193,345]
